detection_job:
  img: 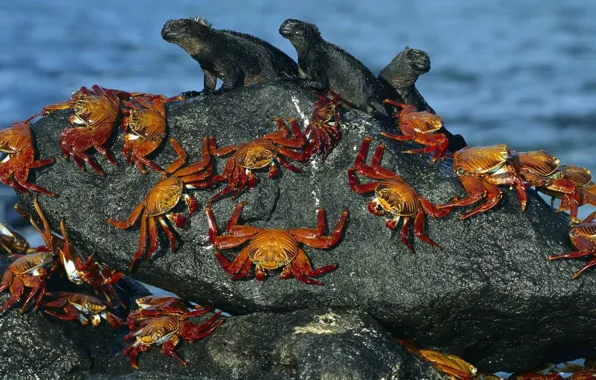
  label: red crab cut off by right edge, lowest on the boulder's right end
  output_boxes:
[548,211,596,278]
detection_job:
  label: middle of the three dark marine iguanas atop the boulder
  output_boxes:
[279,19,388,115]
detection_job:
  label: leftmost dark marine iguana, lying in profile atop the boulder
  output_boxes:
[161,17,298,92]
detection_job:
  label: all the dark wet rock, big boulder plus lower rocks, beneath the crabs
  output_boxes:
[0,81,596,379]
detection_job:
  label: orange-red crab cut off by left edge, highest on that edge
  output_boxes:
[0,115,56,197]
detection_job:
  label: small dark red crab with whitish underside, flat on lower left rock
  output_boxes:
[42,292,124,328]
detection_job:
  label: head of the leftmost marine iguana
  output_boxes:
[161,17,213,54]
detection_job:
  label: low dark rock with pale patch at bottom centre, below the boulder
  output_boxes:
[96,310,443,380]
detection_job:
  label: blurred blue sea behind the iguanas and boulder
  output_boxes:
[0,0,596,236]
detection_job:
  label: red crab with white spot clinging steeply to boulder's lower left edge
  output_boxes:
[29,197,124,304]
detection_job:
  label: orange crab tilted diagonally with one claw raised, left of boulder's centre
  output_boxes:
[108,137,213,270]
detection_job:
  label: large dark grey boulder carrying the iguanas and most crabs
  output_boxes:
[16,83,596,371]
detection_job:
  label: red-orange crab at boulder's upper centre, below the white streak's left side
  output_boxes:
[209,118,306,202]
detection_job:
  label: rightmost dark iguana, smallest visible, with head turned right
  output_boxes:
[379,46,467,152]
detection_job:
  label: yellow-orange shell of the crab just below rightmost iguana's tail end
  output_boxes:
[453,144,509,177]
